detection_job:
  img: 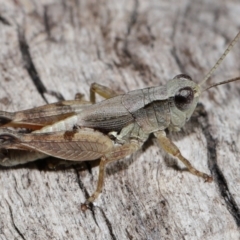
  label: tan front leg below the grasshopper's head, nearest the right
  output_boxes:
[154,131,212,182]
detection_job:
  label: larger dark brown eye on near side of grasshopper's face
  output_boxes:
[174,87,194,110]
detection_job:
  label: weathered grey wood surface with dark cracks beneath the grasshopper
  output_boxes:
[0,0,240,240]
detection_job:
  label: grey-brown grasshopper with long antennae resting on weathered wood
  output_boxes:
[0,32,240,209]
